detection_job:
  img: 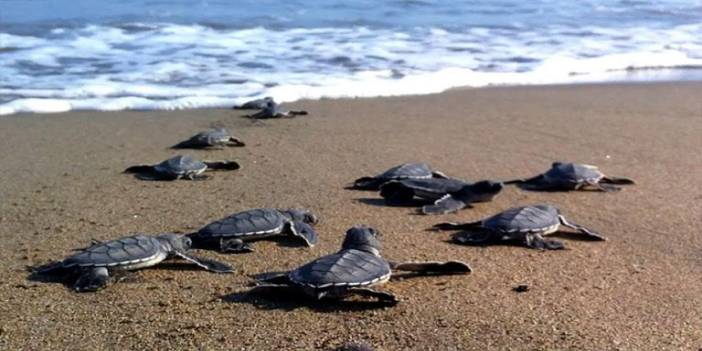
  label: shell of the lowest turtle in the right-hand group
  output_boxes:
[482,205,560,233]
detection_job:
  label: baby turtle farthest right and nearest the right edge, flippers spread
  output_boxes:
[505,162,634,191]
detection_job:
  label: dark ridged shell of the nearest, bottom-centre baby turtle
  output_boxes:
[288,249,390,288]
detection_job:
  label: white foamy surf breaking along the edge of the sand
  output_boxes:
[0,24,702,114]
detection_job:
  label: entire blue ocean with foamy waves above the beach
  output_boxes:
[0,0,702,114]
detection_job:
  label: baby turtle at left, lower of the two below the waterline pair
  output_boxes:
[124,155,239,180]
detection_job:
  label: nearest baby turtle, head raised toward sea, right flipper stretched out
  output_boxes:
[252,226,471,305]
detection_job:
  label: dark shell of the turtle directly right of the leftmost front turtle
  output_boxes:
[198,208,289,238]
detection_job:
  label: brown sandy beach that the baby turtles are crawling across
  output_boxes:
[0,83,702,350]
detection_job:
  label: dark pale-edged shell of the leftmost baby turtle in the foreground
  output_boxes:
[63,235,163,268]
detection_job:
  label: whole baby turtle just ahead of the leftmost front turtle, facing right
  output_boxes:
[188,208,318,252]
